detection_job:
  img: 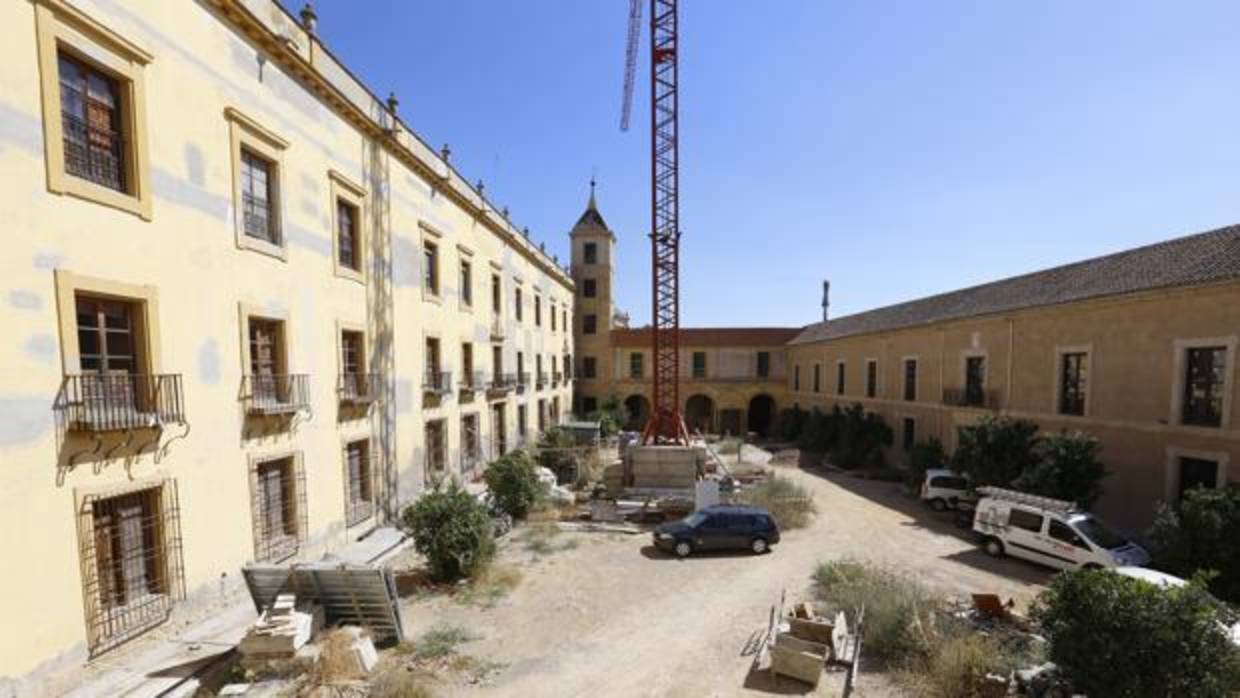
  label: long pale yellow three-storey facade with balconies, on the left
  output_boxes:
[0,0,574,678]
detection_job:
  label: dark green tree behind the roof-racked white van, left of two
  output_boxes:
[951,417,1038,487]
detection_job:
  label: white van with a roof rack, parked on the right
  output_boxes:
[973,487,1149,569]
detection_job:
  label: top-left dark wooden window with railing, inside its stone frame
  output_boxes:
[58,51,129,193]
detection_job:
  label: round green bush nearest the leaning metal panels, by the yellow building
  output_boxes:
[401,484,495,581]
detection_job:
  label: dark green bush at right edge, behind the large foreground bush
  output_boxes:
[1148,485,1240,603]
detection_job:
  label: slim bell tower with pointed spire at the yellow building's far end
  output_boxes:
[569,177,616,418]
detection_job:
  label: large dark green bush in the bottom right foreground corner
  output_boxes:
[1033,570,1240,698]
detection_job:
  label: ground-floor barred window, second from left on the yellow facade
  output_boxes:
[250,455,308,562]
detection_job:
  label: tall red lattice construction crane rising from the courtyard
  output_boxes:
[620,0,688,445]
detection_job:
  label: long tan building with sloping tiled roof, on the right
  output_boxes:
[787,228,1240,533]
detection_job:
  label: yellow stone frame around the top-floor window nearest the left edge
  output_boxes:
[35,0,155,221]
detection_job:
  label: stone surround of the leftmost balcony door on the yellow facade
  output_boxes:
[53,269,162,376]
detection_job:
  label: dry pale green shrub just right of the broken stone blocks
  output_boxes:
[813,560,941,662]
